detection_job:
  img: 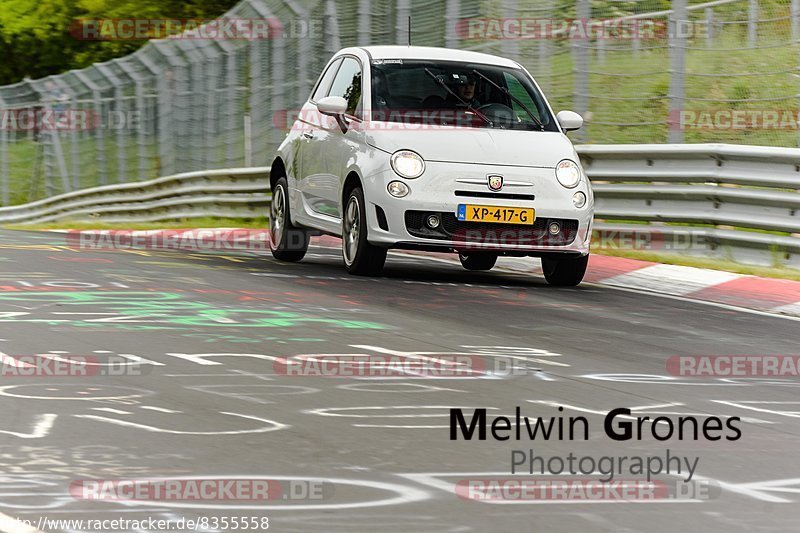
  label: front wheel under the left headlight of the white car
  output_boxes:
[342,187,387,276]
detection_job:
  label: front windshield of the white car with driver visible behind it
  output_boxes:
[371,59,559,131]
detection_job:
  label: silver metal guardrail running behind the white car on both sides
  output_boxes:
[0,144,800,267]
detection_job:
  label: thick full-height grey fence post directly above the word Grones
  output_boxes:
[667,0,689,143]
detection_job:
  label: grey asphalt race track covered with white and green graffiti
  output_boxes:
[0,227,800,533]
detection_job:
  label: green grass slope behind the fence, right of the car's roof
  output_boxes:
[521,8,800,146]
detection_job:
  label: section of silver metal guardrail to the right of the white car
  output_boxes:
[577,144,800,267]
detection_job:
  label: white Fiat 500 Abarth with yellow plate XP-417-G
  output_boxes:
[270,46,594,285]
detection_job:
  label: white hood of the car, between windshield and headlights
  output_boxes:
[366,127,577,168]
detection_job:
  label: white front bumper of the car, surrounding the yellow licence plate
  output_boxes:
[364,162,594,255]
